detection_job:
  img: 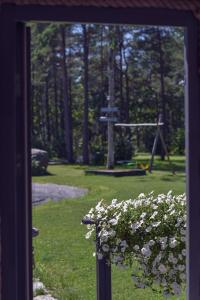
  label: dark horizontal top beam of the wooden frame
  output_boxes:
[14,5,192,26]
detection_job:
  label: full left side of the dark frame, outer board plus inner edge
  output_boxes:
[0,7,33,300]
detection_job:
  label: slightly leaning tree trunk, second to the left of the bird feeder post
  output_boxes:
[61,25,73,163]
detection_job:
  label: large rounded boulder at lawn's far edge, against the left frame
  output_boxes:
[31,149,49,176]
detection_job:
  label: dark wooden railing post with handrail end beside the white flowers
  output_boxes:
[82,219,112,300]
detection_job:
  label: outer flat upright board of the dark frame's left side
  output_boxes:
[0,6,18,300]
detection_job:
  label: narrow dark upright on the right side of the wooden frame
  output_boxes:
[185,15,200,300]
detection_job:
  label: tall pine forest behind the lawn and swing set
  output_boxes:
[31,23,184,164]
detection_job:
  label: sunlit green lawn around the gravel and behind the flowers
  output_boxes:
[33,156,185,300]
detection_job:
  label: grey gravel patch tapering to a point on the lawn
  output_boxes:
[32,183,88,205]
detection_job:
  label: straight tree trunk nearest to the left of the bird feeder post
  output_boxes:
[82,25,89,165]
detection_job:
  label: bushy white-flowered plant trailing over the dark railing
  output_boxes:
[85,191,186,297]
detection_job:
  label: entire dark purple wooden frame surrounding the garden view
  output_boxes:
[0,5,200,300]
